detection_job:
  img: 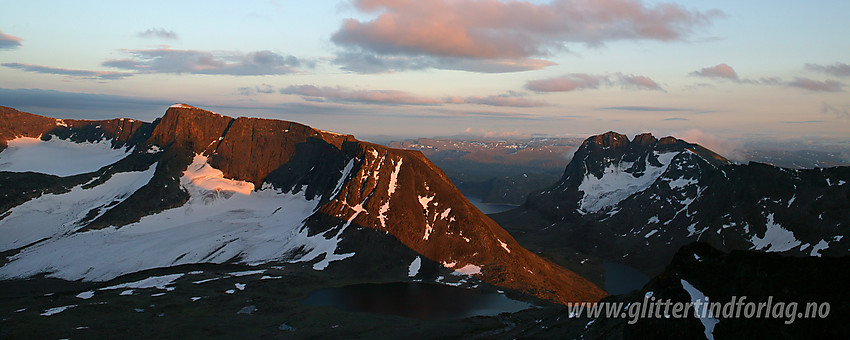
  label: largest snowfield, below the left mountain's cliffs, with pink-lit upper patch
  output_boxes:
[0,156,354,281]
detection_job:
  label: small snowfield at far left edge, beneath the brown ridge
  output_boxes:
[0,137,128,177]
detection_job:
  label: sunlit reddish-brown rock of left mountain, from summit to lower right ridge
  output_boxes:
[149,107,608,303]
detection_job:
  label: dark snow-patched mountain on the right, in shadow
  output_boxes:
[497,132,850,272]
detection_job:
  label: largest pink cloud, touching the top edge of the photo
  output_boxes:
[331,0,723,71]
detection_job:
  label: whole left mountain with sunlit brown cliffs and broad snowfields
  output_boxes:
[0,104,604,302]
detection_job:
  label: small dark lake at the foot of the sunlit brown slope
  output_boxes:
[301,282,532,320]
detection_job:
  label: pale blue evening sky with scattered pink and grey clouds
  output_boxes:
[0,0,850,142]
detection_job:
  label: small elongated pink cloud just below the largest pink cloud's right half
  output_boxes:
[525,73,664,92]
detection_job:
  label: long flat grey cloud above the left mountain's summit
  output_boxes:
[103,47,313,76]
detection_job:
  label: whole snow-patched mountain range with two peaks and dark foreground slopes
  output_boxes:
[0,104,850,339]
